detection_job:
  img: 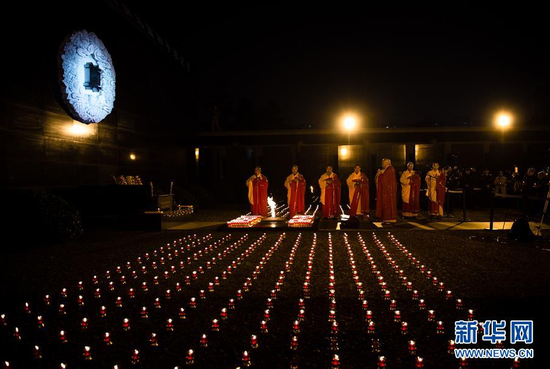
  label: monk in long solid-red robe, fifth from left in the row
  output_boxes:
[374,158,397,224]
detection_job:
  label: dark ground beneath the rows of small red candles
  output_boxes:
[0,203,550,369]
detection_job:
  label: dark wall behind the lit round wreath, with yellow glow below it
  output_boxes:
[0,1,196,189]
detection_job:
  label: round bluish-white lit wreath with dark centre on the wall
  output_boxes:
[59,30,116,124]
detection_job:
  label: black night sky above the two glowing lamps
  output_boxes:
[102,1,550,129]
